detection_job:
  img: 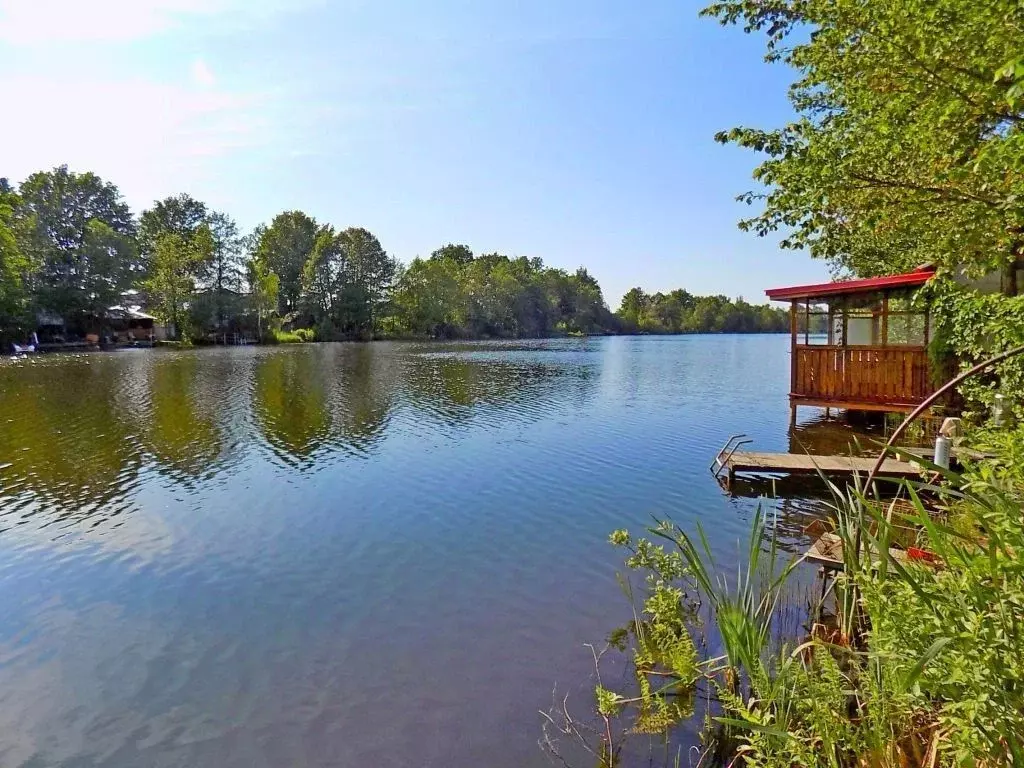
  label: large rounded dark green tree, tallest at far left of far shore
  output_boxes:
[15,166,140,325]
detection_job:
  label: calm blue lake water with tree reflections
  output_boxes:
[0,336,864,768]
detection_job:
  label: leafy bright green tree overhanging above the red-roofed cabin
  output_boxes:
[705,0,1024,292]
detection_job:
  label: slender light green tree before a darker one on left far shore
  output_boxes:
[144,224,214,337]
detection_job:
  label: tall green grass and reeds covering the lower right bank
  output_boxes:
[585,432,1024,768]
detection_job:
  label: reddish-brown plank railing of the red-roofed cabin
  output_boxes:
[792,345,932,404]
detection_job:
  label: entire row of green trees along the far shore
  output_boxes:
[0,166,787,341]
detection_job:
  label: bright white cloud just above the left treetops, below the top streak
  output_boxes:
[0,73,270,207]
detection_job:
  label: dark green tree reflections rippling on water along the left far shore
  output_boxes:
[0,344,598,525]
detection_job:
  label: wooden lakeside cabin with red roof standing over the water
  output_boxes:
[766,267,935,420]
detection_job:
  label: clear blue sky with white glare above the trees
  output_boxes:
[0,0,827,308]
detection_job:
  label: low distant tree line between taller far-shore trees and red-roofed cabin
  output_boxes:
[617,288,790,334]
